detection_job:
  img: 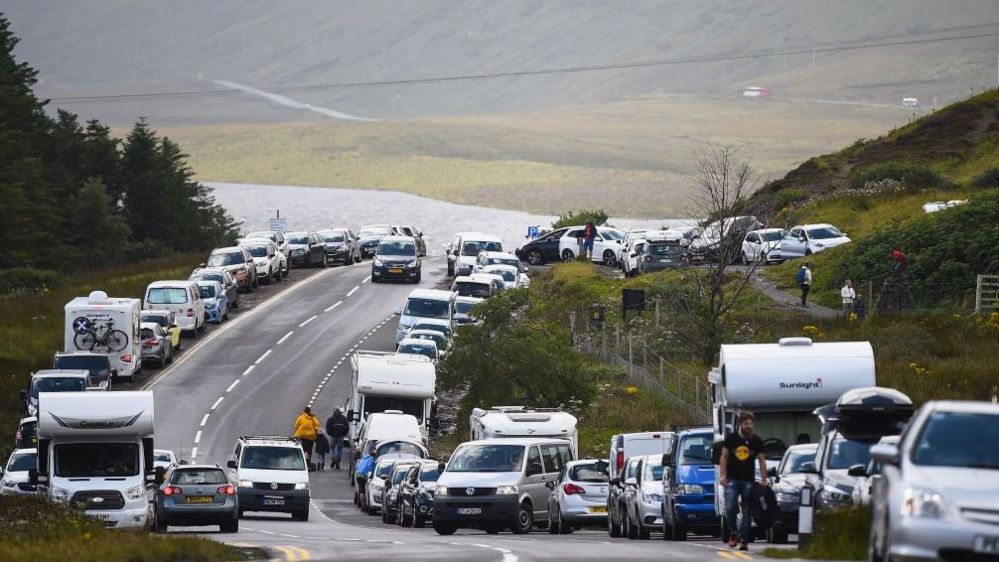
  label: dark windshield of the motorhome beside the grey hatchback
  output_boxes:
[55,443,139,478]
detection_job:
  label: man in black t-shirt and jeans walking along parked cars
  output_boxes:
[718,411,768,550]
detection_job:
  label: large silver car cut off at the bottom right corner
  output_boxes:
[869,402,999,561]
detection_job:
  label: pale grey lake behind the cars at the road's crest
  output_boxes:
[211,182,691,254]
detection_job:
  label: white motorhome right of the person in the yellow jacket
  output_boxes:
[347,350,437,440]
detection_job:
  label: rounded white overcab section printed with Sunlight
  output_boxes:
[711,338,875,409]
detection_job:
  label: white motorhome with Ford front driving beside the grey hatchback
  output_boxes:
[32,391,155,529]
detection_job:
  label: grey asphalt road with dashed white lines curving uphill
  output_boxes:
[139,258,804,562]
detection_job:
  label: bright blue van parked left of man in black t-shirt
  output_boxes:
[663,427,719,541]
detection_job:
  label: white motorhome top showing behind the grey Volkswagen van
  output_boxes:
[468,406,579,456]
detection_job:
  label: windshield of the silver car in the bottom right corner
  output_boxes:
[912,412,999,470]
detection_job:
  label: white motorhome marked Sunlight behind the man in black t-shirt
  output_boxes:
[708,338,875,536]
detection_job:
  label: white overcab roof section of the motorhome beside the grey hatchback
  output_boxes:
[38,391,153,440]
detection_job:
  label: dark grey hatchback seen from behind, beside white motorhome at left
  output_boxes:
[153,465,239,533]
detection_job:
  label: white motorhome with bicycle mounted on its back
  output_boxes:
[63,291,142,381]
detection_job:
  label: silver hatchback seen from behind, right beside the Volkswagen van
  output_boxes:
[546,459,610,535]
